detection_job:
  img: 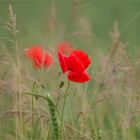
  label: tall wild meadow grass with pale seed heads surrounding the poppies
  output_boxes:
[0,1,140,140]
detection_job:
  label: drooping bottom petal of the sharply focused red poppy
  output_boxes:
[68,71,90,83]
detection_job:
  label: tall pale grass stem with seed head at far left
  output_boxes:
[5,4,23,140]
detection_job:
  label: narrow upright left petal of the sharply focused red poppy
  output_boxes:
[58,52,69,73]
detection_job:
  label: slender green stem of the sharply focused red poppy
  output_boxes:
[60,81,70,139]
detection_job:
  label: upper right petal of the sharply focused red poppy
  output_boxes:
[71,50,91,69]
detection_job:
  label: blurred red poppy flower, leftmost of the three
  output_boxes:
[26,45,53,68]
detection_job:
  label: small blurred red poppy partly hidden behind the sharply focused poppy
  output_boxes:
[58,42,73,55]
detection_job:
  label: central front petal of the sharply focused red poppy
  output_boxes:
[69,54,85,72]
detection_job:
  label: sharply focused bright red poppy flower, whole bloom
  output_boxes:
[58,50,91,83]
